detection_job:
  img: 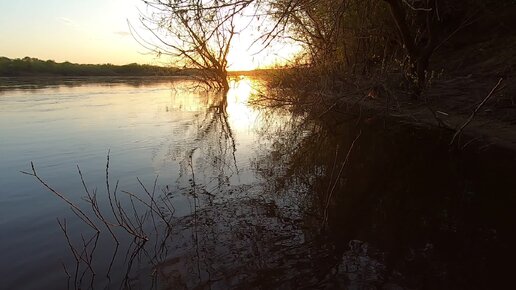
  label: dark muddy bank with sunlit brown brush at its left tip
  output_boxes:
[258,71,516,150]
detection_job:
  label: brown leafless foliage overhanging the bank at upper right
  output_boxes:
[265,0,511,97]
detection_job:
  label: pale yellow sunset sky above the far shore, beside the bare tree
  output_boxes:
[0,0,298,70]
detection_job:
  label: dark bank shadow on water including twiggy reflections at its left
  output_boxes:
[158,103,516,289]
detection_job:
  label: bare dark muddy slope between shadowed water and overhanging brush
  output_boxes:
[325,77,516,150]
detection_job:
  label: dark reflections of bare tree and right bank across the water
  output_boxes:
[18,77,516,289]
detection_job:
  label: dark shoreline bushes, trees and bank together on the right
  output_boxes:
[258,0,516,150]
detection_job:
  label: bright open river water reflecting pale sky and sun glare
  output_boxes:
[0,80,278,289]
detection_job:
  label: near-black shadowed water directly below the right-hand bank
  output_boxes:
[246,107,516,289]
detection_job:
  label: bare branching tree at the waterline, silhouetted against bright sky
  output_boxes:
[132,0,256,91]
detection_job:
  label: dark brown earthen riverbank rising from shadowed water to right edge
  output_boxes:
[330,77,516,150]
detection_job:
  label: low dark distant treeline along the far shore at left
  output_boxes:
[0,57,195,77]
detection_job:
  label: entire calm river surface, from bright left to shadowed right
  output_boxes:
[0,78,516,289]
